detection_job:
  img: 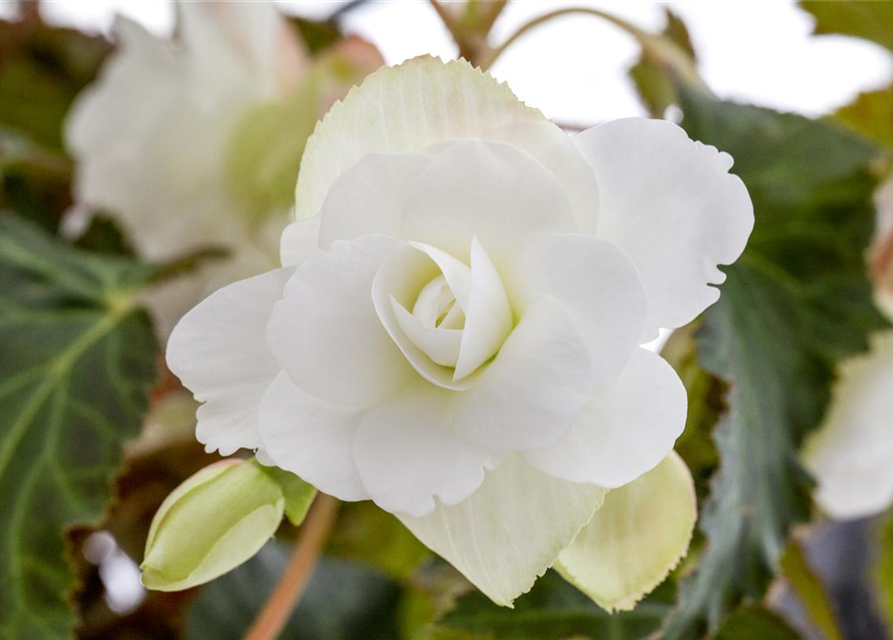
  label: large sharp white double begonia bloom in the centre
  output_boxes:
[168,58,753,608]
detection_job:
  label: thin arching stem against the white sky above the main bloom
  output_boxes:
[481,7,710,94]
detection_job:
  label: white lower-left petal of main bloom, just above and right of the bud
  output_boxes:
[260,371,369,500]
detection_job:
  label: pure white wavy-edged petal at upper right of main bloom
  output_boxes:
[574,118,753,342]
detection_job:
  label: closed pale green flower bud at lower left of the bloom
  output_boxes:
[140,460,285,591]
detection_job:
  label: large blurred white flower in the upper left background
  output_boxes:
[66,2,381,336]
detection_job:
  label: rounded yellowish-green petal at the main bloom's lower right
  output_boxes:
[555,452,697,611]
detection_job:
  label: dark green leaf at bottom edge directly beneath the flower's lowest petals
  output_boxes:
[430,571,673,640]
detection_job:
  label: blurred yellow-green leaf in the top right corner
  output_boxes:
[800,0,893,51]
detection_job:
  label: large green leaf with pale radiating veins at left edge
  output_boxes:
[0,215,164,640]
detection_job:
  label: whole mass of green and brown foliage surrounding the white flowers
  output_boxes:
[0,0,893,640]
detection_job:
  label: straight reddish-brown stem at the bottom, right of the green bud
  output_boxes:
[243,493,338,640]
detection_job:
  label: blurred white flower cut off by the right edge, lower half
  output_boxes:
[804,333,893,520]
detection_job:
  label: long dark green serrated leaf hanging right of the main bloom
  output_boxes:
[665,92,884,640]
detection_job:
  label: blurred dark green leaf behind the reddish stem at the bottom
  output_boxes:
[185,543,400,640]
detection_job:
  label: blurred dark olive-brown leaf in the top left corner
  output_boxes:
[0,12,112,150]
